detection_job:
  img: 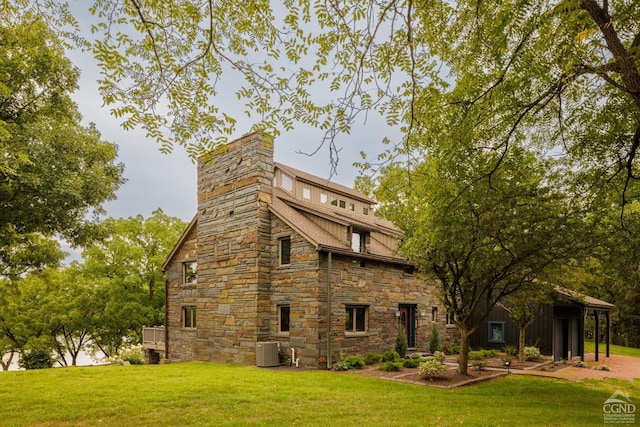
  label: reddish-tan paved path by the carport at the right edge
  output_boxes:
[511,353,640,381]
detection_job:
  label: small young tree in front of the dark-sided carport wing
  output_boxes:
[496,282,552,362]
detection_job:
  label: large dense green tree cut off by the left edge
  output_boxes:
[0,10,122,277]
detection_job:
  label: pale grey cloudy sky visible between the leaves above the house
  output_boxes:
[69,2,400,226]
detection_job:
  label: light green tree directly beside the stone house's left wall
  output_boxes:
[82,209,186,357]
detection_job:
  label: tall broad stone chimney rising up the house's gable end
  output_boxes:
[196,133,273,364]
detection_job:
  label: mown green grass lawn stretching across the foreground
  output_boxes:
[0,362,640,426]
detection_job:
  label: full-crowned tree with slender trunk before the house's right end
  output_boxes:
[376,147,573,374]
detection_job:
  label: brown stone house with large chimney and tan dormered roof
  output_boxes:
[161,133,457,368]
